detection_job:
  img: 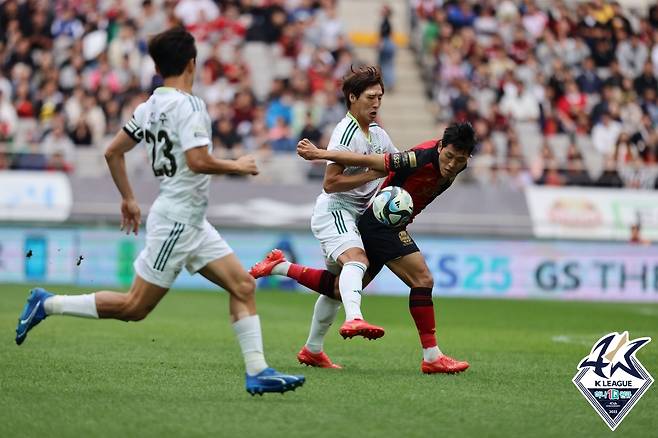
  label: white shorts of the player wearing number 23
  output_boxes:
[133,213,233,289]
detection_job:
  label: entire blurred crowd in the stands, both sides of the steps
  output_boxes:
[0,0,658,189]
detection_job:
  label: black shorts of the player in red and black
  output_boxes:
[358,208,420,274]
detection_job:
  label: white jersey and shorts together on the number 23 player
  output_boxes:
[123,87,232,287]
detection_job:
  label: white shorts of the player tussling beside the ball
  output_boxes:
[311,208,363,262]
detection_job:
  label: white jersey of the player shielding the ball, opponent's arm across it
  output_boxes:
[315,113,398,215]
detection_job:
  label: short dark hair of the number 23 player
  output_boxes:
[149,27,196,78]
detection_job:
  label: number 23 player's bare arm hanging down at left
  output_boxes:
[105,130,141,235]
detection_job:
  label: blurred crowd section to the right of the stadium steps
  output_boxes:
[411,0,658,188]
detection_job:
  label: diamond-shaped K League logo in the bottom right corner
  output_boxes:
[573,332,653,430]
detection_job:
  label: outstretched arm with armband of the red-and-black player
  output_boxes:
[297,138,434,172]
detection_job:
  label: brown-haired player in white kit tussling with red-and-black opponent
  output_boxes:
[250,67,398,368]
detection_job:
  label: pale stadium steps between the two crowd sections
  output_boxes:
[339,0,443,149]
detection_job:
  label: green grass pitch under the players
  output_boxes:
[0,285,658,438]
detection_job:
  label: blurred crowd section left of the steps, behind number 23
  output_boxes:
[0,0,356,175]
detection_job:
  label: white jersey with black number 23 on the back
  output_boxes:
[123,87,212,226]
